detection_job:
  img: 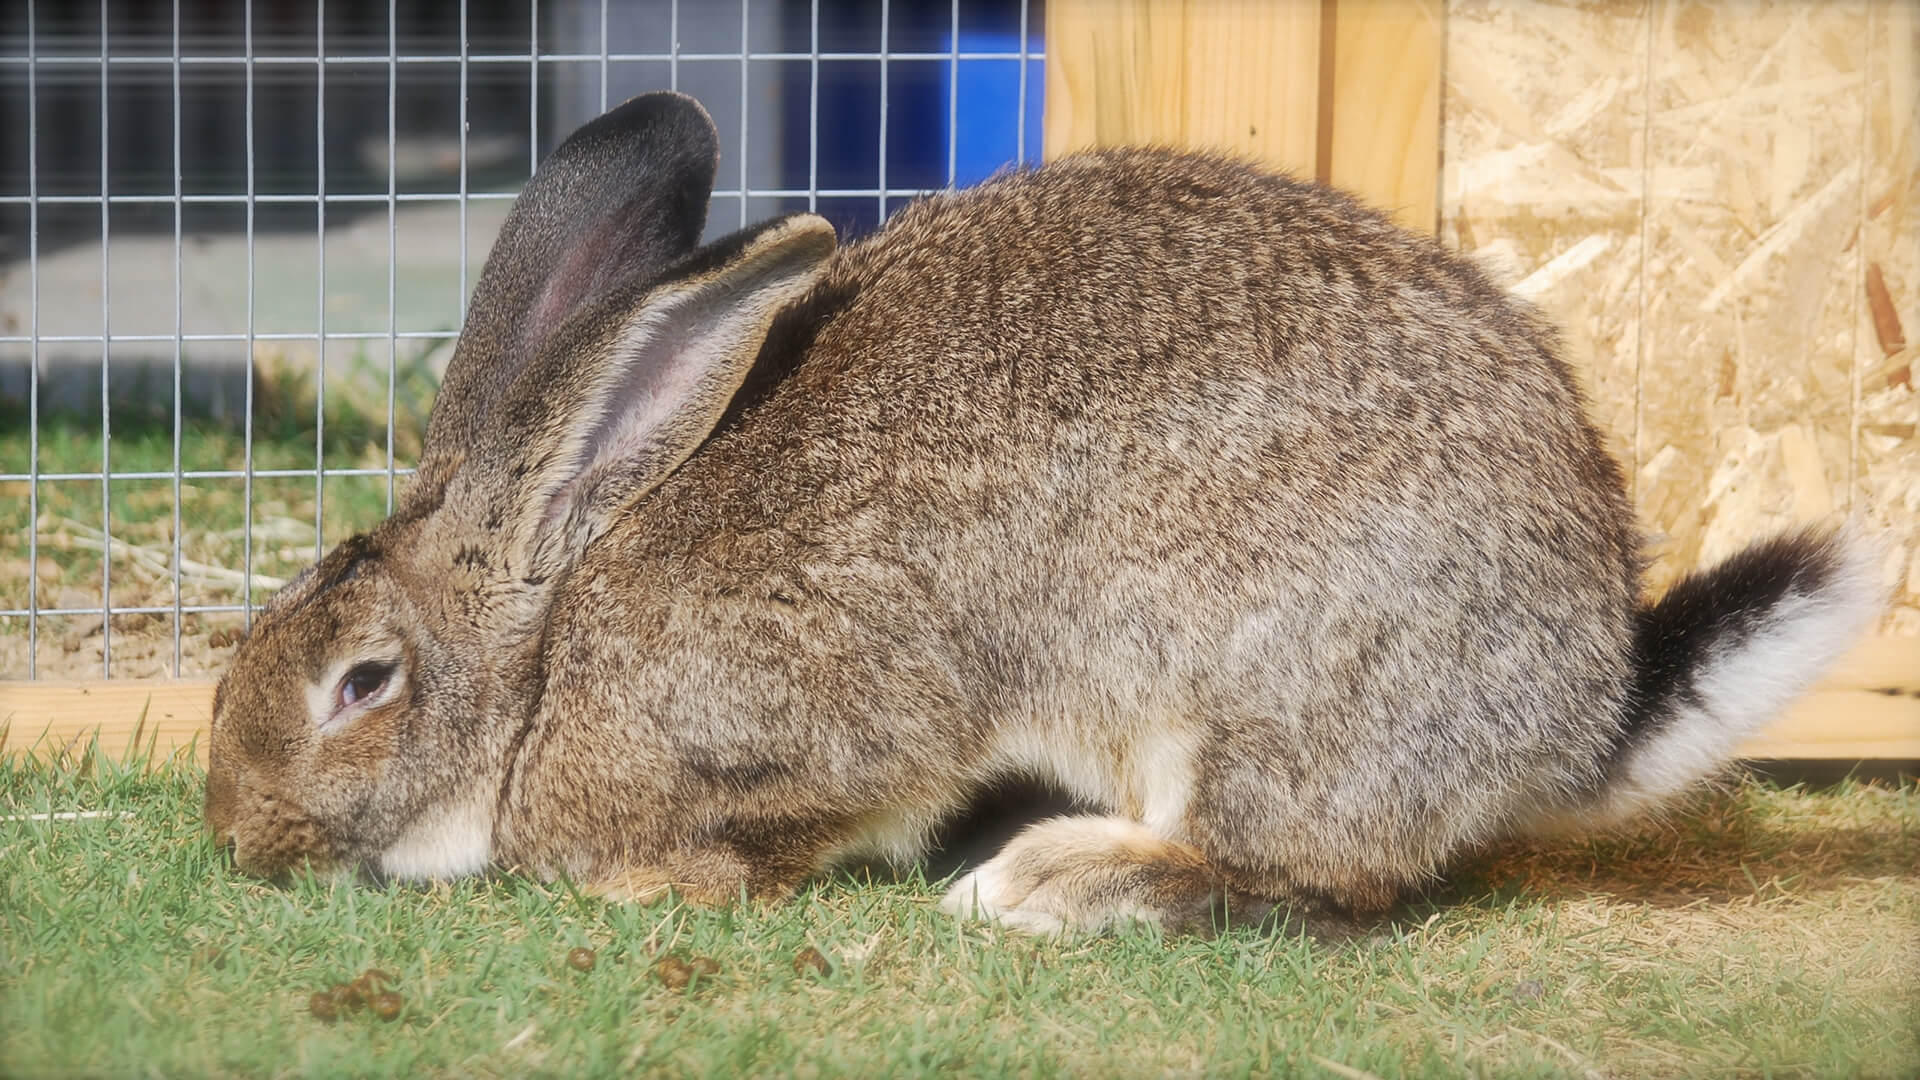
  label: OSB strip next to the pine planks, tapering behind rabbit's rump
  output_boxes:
[1442,0,1649,477]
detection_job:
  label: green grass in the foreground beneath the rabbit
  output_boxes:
[0,749,1920,1078]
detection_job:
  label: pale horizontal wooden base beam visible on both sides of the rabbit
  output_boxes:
[0,638,1920,765]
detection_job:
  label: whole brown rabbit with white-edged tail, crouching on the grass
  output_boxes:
[207,94,1882,930]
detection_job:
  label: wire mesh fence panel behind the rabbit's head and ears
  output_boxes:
[0,0,1044,678]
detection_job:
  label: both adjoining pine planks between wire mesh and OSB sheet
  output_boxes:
[1044,0,1444,233]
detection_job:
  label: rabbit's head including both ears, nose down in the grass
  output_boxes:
[205,94,833,876]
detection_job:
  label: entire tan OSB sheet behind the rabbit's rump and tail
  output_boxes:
[1442,0,1920,636]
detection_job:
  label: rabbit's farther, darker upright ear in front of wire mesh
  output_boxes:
[409,92,720,494]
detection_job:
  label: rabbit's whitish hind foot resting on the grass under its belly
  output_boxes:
[941,815,1221,934]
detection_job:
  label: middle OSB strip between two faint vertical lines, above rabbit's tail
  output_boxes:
[1636,0,1868,586]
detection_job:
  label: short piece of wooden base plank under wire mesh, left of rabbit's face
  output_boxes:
[0,678,213,765]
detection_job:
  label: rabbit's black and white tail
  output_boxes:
[1576,528,1885,824]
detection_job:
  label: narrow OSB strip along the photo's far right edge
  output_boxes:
[1853,0,1920,636]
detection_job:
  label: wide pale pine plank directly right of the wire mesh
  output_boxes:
[1044,0,1321,177]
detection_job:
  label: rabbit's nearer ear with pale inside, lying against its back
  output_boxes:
[472,213,833,577]
